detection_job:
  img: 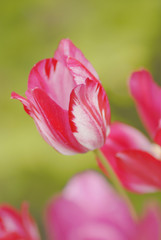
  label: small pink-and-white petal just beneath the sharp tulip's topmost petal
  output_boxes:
[67,57,98,84]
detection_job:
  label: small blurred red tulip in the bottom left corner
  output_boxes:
[0,203,40,240]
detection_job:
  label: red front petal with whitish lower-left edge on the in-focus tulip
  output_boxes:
[32,88,87,155]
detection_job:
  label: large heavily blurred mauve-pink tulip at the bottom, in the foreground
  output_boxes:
[46,171,161,240]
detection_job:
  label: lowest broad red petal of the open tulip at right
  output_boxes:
[116,150,161,193]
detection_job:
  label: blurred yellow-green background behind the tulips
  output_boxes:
[0,0,161,238]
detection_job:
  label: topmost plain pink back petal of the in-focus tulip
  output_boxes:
[54,39,99,79]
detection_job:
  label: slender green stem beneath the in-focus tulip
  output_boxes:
[94,149,137,219]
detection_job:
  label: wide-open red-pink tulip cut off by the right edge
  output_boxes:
[100,70,161,193]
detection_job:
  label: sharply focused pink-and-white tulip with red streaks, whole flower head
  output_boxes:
[12,39,110,155]
